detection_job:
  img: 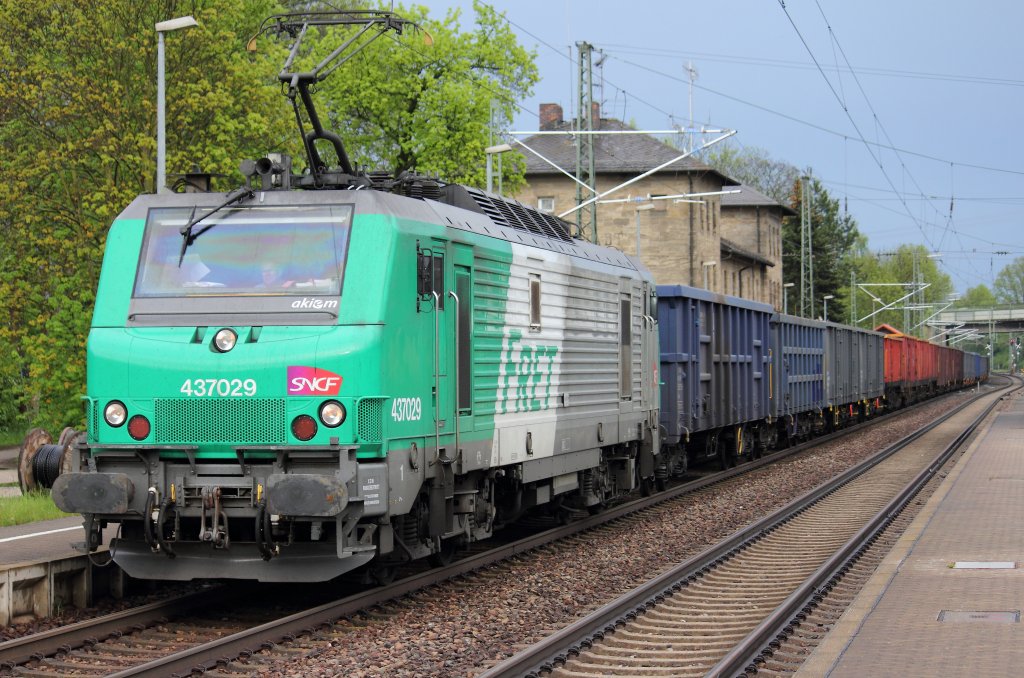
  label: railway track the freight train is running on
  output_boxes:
[0,391,991,677]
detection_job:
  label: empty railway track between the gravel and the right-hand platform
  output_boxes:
[481,378,1015,678]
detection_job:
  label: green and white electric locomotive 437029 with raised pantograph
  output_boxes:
[53,12,658,582]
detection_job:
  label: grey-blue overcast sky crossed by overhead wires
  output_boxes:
[423,0,1024,292]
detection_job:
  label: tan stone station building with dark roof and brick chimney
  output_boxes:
[515,103,793,308]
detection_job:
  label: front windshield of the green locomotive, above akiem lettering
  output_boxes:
[134,205,352,298]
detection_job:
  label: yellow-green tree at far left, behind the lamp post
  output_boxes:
[0,0,289,431]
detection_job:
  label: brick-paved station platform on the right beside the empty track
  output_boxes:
[797,395,1024,678]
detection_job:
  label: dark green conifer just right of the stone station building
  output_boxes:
[782,179,866,322]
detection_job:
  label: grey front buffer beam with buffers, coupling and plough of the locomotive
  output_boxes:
[53,446,387,582]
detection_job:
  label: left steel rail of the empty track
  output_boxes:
[477,378,1007,678]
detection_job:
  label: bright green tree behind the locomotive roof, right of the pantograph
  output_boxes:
[306,2,538,193]
